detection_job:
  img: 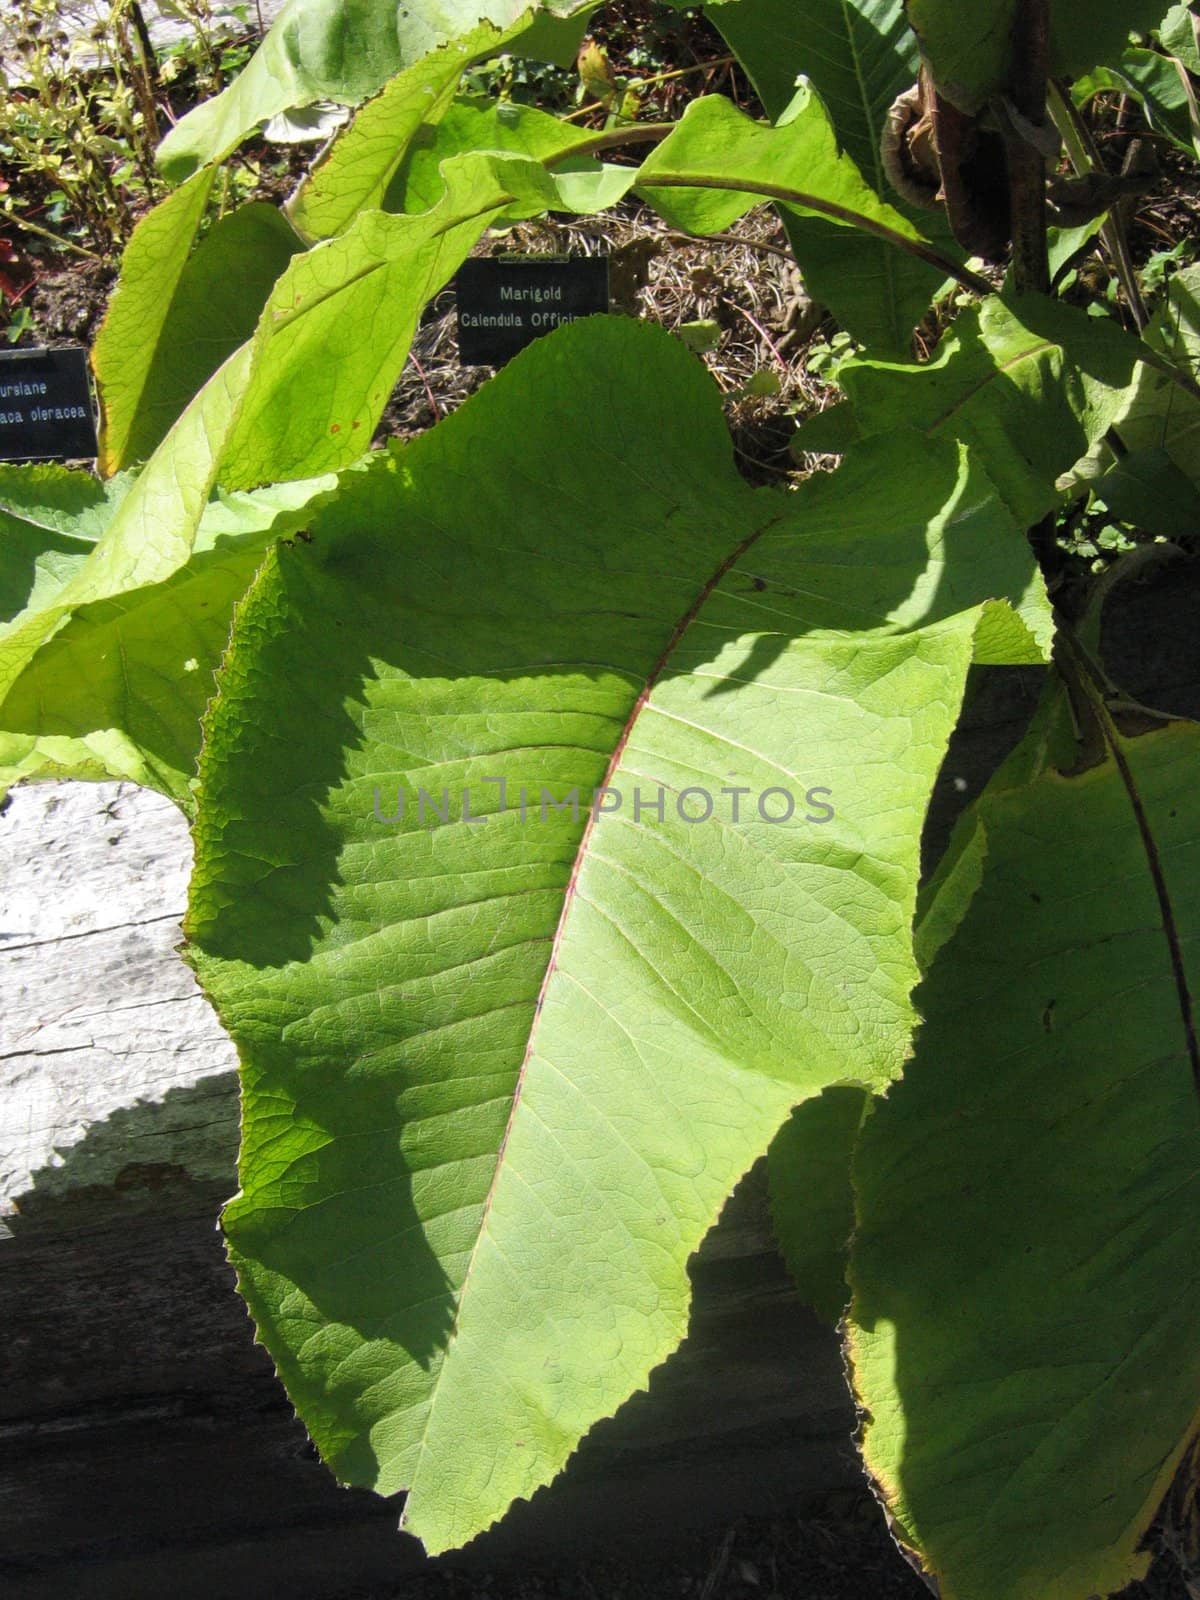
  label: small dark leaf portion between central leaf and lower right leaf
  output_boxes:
[766,1083,872,1323]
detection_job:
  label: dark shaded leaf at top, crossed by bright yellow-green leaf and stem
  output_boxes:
[709,0,960,355]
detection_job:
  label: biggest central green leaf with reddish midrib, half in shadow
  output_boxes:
[187,318,1037,1549]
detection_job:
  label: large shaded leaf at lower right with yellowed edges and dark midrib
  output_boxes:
[851,691,1200,1600]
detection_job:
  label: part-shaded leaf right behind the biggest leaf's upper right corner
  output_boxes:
[838,296,1144,528]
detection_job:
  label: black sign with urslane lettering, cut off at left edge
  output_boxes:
[0,347,96,461]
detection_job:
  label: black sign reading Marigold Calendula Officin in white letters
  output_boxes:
[456,256,608,366]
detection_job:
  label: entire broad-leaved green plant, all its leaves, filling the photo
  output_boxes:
[0,0,1200,1600]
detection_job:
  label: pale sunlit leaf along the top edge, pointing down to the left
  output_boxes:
[158,0,592,182]
